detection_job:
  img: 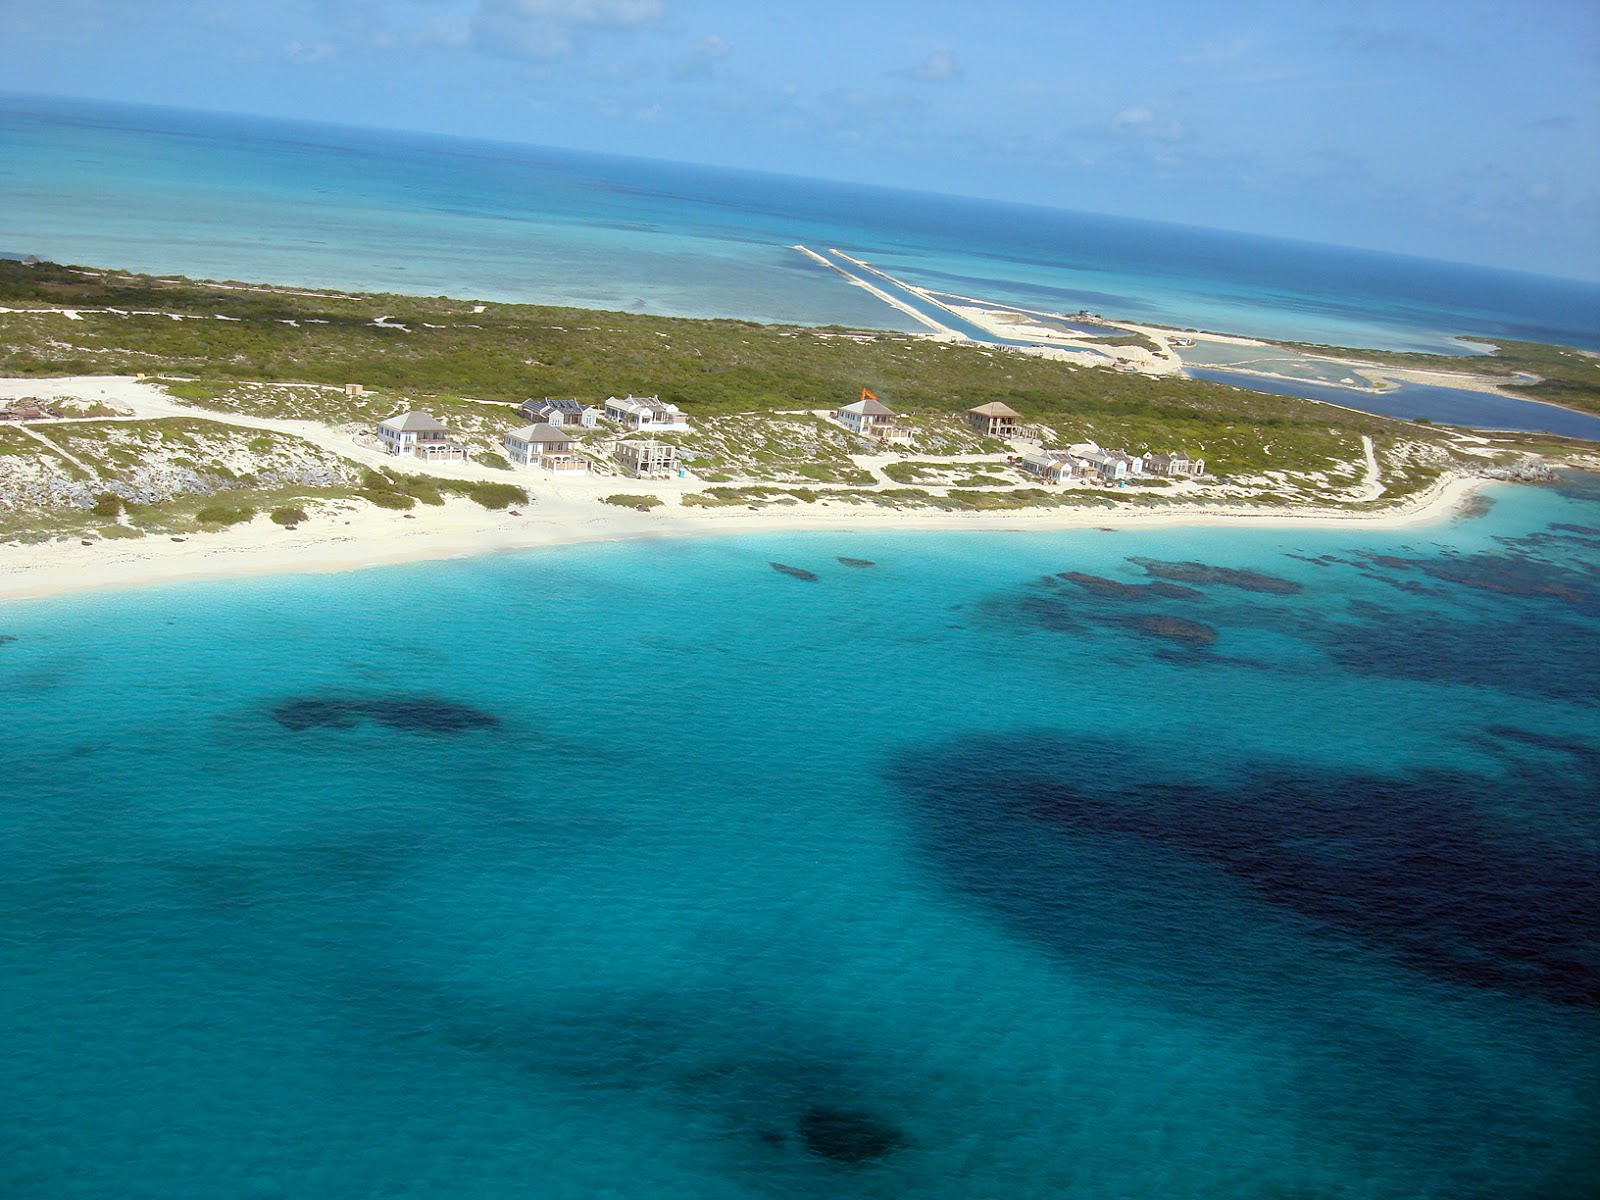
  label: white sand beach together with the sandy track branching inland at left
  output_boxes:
[0,376,1483,600]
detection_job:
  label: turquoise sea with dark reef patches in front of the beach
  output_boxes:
[0,477,1600,1200]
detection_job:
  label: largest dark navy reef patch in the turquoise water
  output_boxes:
[894,733,1600,1008]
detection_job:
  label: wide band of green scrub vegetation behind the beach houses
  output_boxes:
[0,262,1454,482]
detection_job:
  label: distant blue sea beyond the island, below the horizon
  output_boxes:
[0,96,1600,352]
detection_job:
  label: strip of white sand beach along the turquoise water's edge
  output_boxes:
[0,477,1485,600]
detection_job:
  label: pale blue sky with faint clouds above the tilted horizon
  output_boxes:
[0,0,1600,278]
